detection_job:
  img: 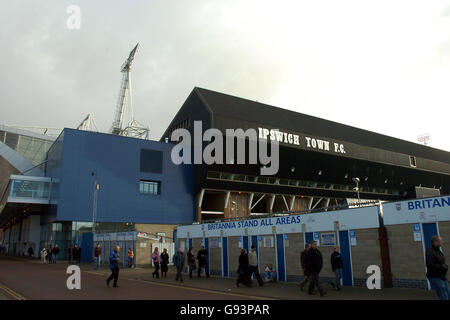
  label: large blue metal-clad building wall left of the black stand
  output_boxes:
[46,129,195,224]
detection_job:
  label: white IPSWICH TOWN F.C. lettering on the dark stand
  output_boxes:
[258,127,346,154]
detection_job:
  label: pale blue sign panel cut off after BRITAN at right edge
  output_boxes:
[383,196,450,225]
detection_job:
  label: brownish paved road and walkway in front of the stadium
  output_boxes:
[0,256,436,300]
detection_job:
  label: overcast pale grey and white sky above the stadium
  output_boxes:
[0,0,450,151]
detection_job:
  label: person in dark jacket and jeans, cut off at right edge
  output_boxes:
[425,236,450,300]
